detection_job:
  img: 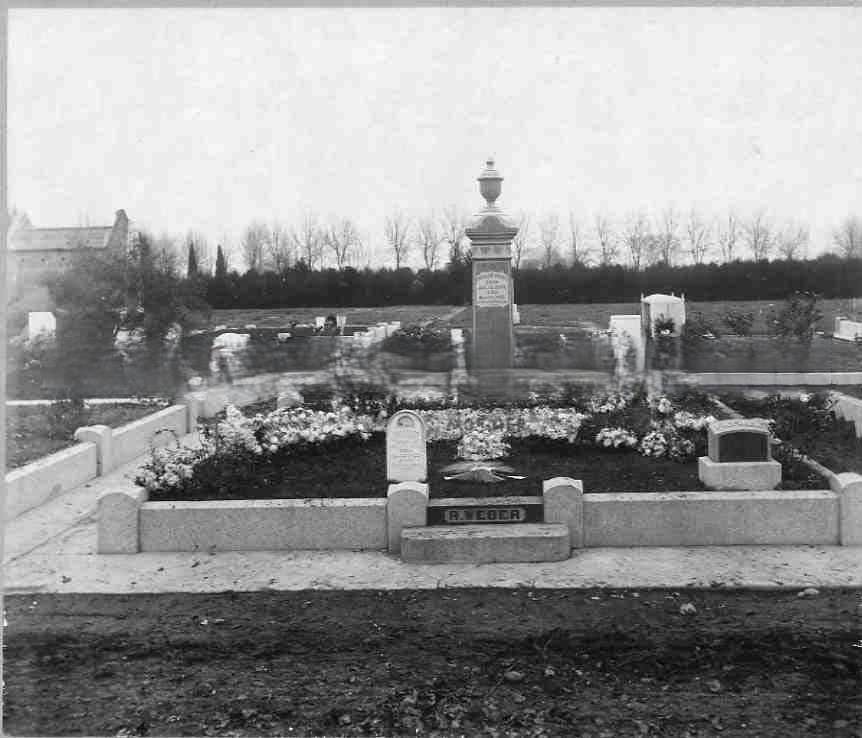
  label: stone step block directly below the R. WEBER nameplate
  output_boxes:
[401,523,571,564]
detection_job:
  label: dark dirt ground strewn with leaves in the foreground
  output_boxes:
[4,589,862,738]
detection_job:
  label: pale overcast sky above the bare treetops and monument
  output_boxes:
[7,7,862,262]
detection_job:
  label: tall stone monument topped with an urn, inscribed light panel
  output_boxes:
[467,159,518,369]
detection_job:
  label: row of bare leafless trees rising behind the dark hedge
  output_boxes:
[143,207,862,272]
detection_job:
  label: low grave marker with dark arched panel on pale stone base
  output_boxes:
[698,418,781,490]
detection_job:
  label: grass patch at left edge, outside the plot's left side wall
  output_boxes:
[6,403,170,469]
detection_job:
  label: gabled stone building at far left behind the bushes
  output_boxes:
[6,210,129,312]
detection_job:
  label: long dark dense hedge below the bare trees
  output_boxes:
[195,254,862,308]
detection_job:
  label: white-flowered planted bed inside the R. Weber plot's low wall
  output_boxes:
[136,391,826,501]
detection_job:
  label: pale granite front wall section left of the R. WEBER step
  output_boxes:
[140,497,386,551]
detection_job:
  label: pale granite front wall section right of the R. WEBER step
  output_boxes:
[584,490,839,546]
